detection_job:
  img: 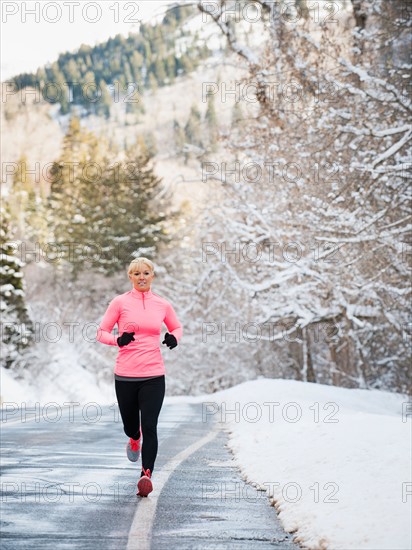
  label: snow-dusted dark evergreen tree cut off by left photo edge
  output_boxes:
[0,206,33,368]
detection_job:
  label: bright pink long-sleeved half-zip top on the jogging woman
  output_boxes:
[97,288,183,378]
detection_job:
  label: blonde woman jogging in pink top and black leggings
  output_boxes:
[97,258,182,497]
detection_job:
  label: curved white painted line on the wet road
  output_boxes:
[127,430,218,550]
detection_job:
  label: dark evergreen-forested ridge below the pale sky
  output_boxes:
[10,6,209,117]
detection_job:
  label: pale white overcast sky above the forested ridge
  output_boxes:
[1,0,177,80]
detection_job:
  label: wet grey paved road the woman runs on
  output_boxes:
[0,403,298,550]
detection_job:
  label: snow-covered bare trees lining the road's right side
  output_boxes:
[193,0,412,391]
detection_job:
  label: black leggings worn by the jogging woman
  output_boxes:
[114,375,165,472]
